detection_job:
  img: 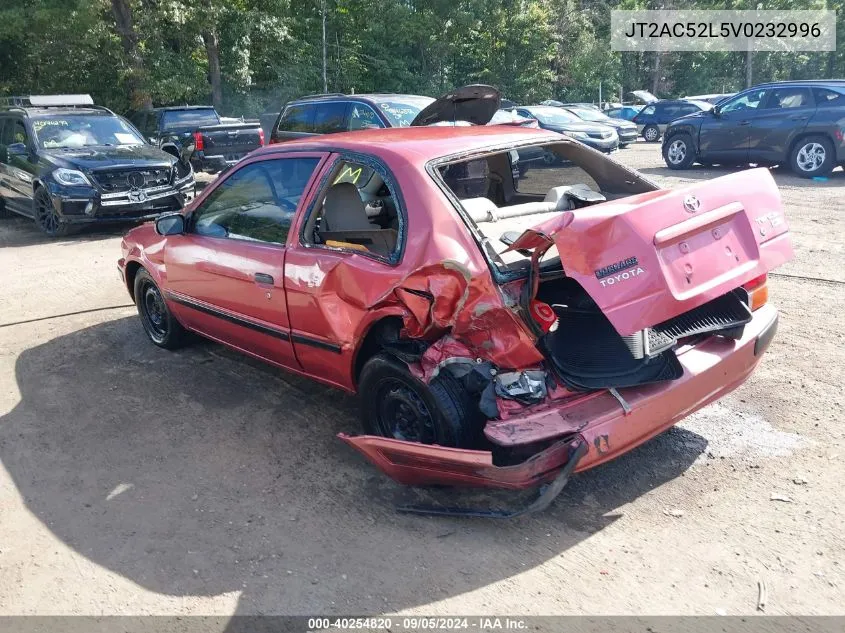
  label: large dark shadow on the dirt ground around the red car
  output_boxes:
[0,318,707,614]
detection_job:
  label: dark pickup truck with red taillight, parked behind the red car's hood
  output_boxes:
[130,106,264,173]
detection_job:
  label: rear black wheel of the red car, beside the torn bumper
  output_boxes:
[358,354,482,448]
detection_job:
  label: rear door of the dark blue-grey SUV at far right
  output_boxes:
[748,86,816,162]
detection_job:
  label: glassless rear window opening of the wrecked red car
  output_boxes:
[437,141,657,273]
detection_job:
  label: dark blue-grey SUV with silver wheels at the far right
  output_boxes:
[663,80,845,178]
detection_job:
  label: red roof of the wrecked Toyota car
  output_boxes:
[252,125,566,165]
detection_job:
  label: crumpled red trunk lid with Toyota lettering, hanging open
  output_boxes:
[510,168,792,336]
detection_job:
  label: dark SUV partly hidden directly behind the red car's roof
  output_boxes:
[270,93,434,143]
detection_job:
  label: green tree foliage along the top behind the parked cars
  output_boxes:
[0,0,845,116]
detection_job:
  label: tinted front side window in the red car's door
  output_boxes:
[193,158,319,245]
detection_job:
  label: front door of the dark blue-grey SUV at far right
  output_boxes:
[699,89,766,163]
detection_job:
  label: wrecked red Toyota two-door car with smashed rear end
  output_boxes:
[119,126,792,512]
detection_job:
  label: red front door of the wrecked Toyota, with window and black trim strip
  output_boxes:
[164,153,325,369]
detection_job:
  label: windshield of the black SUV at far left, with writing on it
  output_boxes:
[32,115,144,149]
